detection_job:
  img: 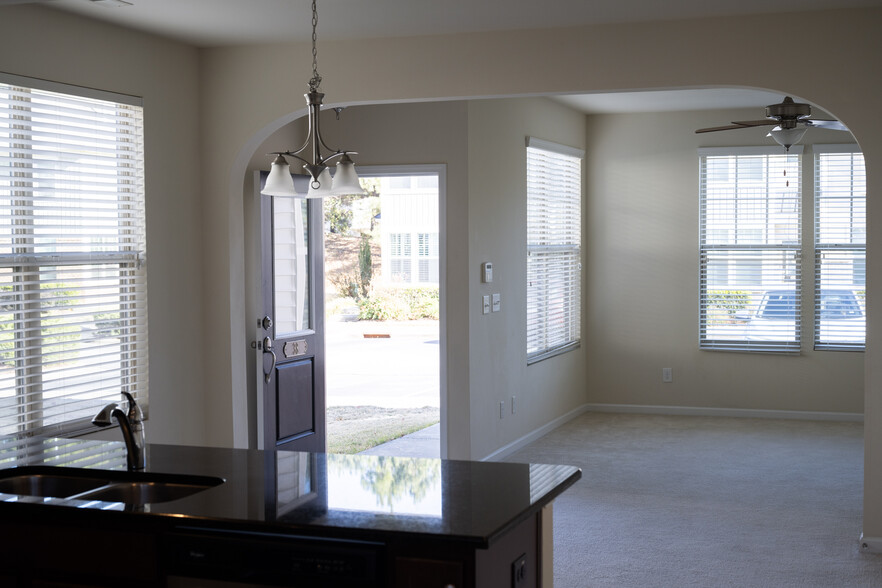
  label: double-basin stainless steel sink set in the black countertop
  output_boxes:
[0,466,224,505]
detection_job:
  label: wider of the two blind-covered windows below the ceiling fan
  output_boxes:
[699,146,802,352]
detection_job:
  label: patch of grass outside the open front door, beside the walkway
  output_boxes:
[327,406,440,453]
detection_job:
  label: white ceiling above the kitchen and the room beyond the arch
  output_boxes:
[8,0,882,113]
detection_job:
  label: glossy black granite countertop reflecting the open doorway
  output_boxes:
[0,437,581,547]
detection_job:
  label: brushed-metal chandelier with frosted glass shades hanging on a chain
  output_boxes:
[261,0,364,198]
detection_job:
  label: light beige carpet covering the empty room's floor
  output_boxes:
[508,413,882,588]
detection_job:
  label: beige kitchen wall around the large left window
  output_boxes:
[0,6,205,444]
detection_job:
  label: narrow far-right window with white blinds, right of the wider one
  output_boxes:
[814,145,867,351]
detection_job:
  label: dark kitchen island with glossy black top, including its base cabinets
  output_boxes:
[0,437,581,588]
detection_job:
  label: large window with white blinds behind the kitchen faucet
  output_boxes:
[0,75,147,434]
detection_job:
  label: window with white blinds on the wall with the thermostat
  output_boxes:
[527,137,584,363]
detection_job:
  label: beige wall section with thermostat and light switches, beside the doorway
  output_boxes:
[464,98,587,459]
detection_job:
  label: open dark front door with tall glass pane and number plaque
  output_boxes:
[258,172,325,452]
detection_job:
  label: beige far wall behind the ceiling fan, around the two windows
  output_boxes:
[585,109,864,413]
